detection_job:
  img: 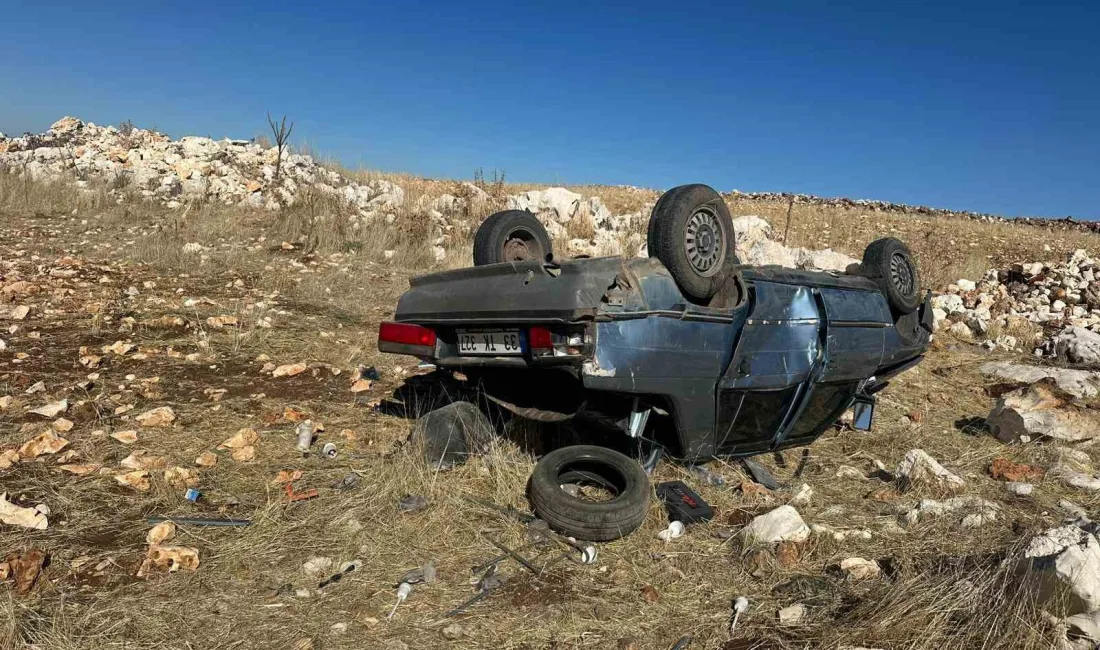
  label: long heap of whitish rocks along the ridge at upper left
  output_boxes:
[0,117,405,218]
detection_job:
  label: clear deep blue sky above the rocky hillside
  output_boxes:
[0,0,1100,218]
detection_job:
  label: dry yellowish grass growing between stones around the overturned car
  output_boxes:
[0,176,1100,650]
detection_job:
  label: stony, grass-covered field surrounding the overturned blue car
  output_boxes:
[0,118,1100,649]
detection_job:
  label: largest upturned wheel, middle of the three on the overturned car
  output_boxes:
[646,184,738,300]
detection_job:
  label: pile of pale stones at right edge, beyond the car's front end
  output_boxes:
[932,249,1100,364]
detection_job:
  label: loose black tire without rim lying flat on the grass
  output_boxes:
[528,444,650,541]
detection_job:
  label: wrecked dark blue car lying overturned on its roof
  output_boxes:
[378,185,933,539]
